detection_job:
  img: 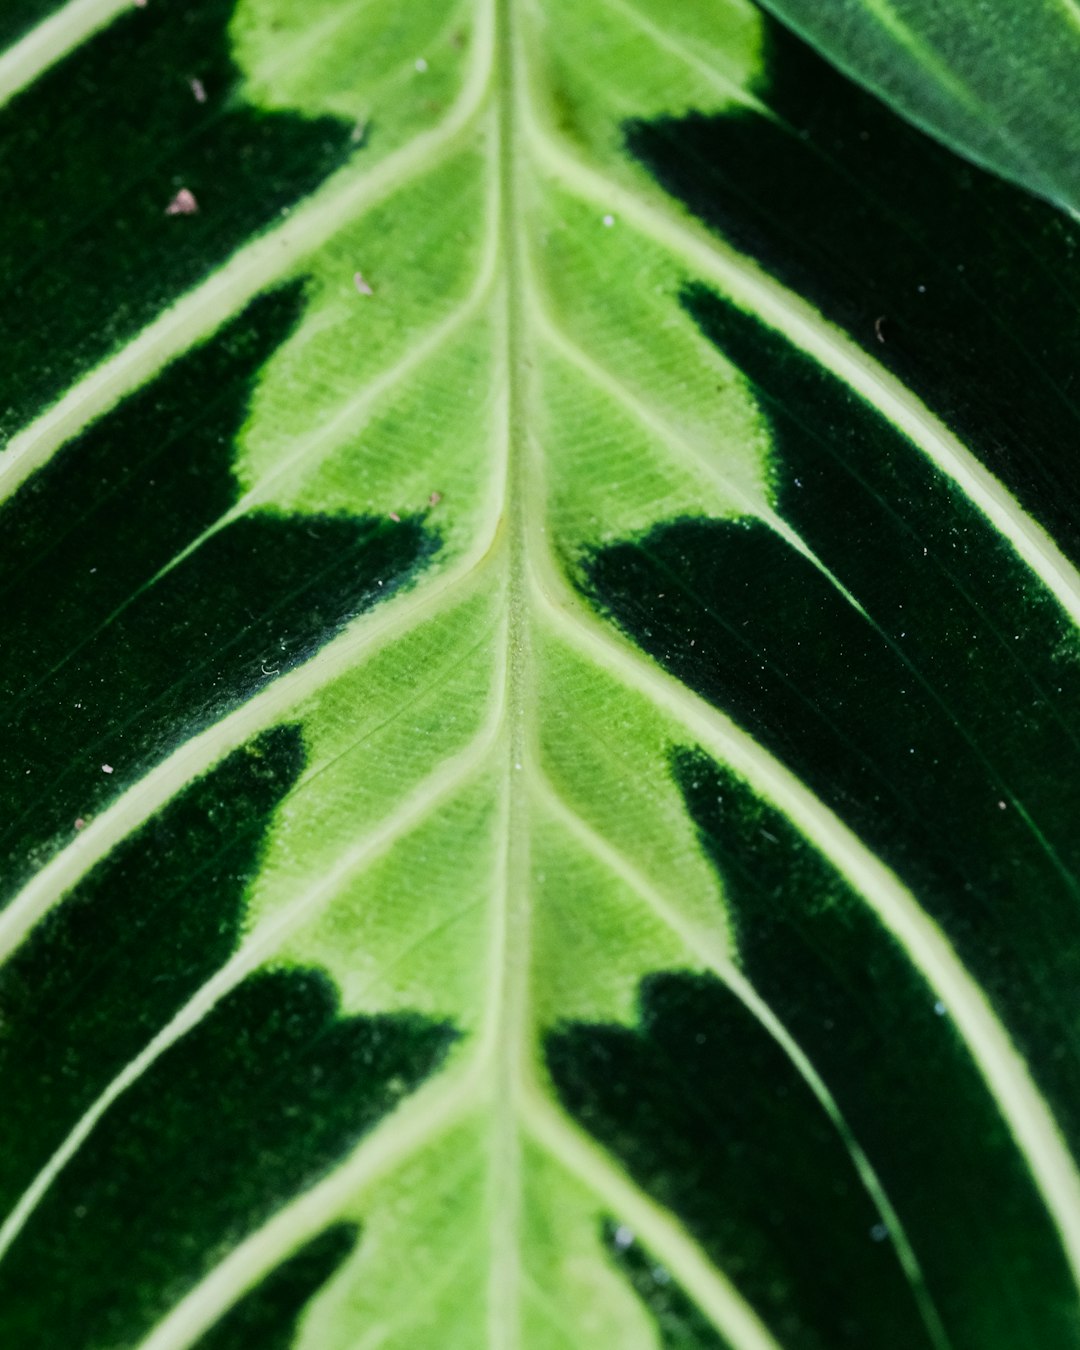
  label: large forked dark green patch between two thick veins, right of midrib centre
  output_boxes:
[587,288,1080,1161]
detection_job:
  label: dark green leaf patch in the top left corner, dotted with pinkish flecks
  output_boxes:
[0,0,352,440]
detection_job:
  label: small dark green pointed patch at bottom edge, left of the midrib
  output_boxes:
[194,1223,358,1350]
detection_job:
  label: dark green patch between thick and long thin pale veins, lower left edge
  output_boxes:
[0,728,304,1212]
